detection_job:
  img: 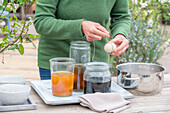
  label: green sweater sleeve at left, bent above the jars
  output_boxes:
[34,0,83,40]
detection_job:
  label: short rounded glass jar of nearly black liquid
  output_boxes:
[83,62,111,94]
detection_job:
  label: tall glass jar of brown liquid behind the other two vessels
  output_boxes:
[70,41,90,91]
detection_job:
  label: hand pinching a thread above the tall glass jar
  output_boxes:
[81,21,110,41]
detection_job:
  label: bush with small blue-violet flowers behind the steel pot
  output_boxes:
[110,0,170,75]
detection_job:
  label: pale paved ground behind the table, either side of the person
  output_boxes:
[0,21,170,80]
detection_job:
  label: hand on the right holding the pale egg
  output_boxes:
[110,34,129,56]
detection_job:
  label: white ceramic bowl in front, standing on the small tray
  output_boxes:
[0,84,31,105]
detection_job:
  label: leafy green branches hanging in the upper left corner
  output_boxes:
[0,0,38,59]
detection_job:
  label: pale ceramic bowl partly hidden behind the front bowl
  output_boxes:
[0,75,26,85]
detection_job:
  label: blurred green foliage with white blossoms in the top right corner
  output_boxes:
[129,0,170,26]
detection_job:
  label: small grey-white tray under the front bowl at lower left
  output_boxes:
[0,96,37,112]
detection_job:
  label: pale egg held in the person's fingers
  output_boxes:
[104,42,116,53]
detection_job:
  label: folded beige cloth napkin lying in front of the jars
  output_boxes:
[79,93,130,113]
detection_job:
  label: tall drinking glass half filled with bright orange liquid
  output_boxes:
[50,58,75,96]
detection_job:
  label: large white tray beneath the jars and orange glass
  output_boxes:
[30,80,133,105]
